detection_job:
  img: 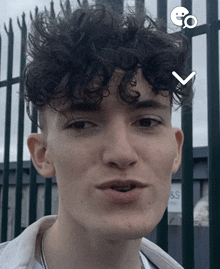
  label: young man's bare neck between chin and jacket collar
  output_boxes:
[36,218,141,269]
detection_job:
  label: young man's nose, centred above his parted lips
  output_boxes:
[103,123,138,169]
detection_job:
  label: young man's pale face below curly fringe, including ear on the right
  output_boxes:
[30,69,182,240]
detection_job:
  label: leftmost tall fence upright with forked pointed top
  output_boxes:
[1,19,14,242]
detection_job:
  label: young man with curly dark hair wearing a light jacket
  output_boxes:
[0,1,191,269]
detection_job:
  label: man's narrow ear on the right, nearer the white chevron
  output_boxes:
[172,128,184,174]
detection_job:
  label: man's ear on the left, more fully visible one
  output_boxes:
[27,133,55,178]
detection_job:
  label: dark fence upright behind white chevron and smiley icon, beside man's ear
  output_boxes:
[182,0,194,269]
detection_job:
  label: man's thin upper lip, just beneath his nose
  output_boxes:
[96,179,147,190]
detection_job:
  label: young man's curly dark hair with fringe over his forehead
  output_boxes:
[24,0,192,124]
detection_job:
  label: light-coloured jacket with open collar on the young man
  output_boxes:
[0,216,183,269]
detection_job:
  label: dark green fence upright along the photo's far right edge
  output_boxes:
[206,0,220,269]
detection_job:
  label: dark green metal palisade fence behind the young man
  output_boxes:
[0,0,220,269]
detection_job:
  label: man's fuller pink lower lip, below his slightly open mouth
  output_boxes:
[99,188,144,204]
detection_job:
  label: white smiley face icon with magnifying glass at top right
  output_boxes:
[170,7,198,29]
